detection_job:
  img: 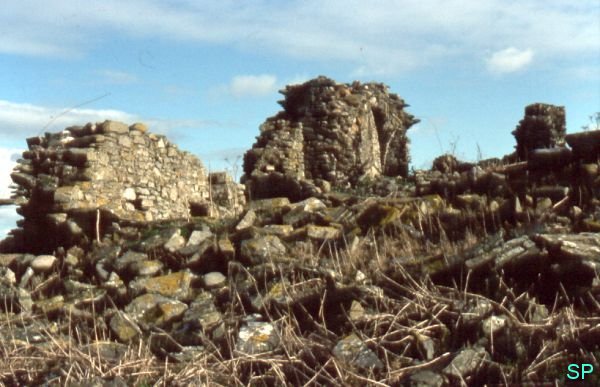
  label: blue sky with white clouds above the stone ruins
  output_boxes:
[0,0,600,237]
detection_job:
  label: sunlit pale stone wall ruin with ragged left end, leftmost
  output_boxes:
[4,121,244,252]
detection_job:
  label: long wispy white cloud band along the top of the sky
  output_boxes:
[0,0,600,75]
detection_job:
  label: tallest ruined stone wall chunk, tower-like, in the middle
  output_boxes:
[242,77,418,199]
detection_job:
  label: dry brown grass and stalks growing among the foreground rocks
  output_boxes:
[0,226,600,386]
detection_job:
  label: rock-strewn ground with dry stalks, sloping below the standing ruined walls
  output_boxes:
[0,172,600,386]
